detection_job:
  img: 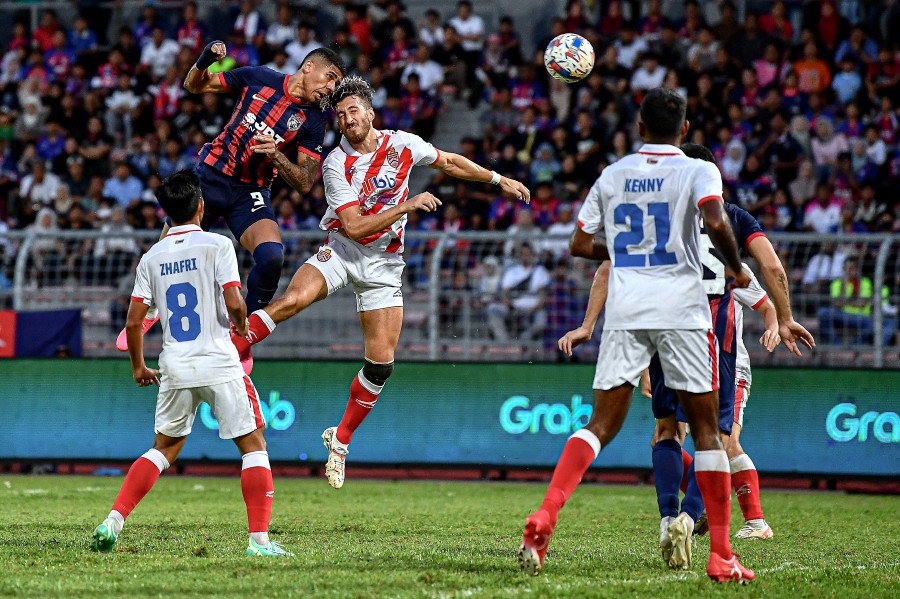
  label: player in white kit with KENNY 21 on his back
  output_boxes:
[519,88,754,582]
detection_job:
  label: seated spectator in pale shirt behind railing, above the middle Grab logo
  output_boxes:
[487,244,550,341]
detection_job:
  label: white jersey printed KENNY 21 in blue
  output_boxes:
[578,144,722,330]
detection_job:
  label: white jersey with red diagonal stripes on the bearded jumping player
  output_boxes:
[319,131,440,253]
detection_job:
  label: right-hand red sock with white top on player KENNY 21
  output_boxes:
[694,449,733,559]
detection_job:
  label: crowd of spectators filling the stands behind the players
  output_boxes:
[0,0,900,352]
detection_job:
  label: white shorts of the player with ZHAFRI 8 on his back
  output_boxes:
[155,375,265,439]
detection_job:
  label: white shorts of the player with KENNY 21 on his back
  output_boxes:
[594,329,719,393]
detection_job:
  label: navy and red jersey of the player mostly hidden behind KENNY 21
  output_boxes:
[700,204,765,353]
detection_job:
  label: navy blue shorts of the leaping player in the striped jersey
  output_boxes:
[194,162,275,241]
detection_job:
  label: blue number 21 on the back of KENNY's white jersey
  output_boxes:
[613,202,678,268]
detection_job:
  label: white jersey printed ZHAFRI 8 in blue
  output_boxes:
[131,225,244,391]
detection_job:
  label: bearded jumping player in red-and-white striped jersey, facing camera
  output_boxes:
[232,77,531,489]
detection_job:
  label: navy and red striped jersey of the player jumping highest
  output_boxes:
[200,67,325,187]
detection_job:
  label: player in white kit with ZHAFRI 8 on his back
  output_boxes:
[91,170,291,556]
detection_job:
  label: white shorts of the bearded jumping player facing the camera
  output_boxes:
[306,233,406,312]
